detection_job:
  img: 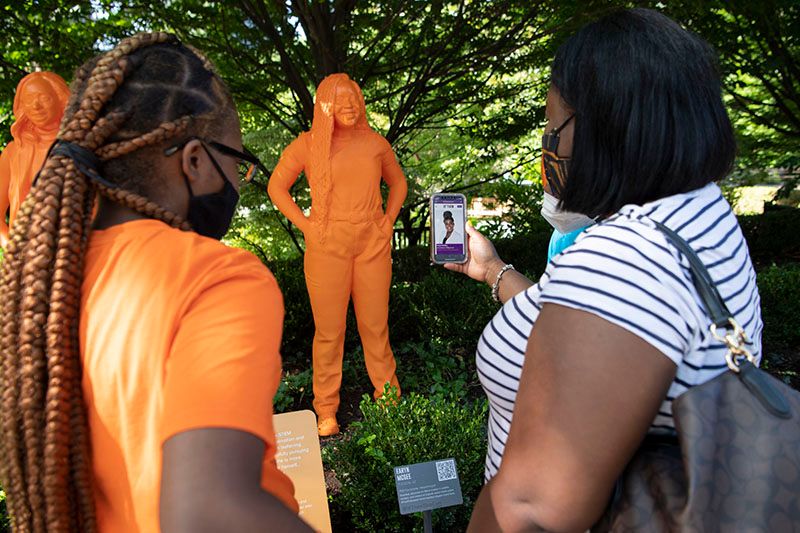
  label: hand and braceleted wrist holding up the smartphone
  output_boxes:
[444,223,533,303]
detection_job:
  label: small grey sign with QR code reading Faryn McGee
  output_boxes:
[394,459,464,514]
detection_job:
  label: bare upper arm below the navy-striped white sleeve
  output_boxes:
[469,303,676,532]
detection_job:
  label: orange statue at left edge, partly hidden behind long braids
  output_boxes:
[0,72,69,248]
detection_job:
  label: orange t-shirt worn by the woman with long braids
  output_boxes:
[80,220,298,533]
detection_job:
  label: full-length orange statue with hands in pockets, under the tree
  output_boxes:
[269,74,408,436]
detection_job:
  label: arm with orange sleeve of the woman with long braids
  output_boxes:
[154,258,308,533]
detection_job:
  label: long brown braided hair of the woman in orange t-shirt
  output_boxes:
[0,33,235,532]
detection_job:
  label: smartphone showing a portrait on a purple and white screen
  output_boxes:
[430,193,467,265]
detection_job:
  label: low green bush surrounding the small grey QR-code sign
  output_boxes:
[323,386,486,532]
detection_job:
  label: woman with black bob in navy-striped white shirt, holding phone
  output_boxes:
[447,9,762,531]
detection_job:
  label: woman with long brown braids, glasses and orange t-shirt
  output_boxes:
[0,33,308,533]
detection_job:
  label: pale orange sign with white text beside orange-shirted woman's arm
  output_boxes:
[272,410,331,533]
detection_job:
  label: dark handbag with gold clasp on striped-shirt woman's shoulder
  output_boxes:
[592,222,800,532]
